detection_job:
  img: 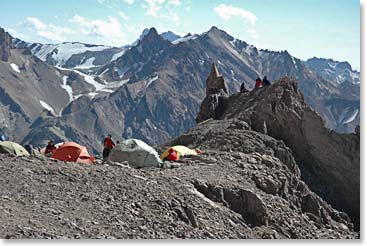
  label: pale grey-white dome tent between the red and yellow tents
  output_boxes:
[108,139,161,168]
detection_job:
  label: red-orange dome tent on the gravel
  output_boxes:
[51,142,94,164]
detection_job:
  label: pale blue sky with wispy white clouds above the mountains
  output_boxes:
[0,0,360,70]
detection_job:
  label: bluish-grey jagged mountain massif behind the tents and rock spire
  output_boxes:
[0,27,359,154]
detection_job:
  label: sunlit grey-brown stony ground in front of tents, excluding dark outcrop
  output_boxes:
[0,128,358,239]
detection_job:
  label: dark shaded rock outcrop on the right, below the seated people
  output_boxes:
[199,78,360,227]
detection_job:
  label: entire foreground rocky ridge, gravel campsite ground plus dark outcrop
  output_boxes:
[0,78,359,239]
